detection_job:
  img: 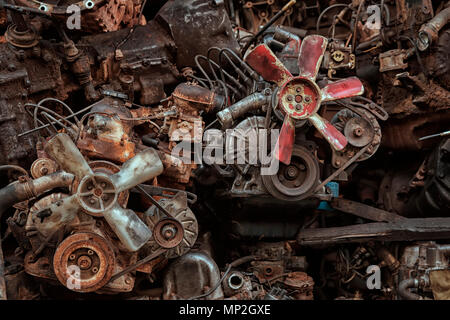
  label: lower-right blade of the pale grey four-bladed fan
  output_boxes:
[103,205,152,252]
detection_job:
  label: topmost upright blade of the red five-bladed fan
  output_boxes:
[298,35,328,81]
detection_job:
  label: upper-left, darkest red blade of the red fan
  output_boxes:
[245,44,293,87]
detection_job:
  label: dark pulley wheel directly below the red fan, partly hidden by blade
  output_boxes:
[261,145,320,201]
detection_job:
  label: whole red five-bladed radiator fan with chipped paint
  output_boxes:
[245,35,364,164]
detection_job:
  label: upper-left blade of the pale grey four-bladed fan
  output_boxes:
[44,133,93,179]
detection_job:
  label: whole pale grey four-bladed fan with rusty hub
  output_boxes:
[45,134,163,252]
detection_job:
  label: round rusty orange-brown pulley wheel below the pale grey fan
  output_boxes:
[53,233,115,293]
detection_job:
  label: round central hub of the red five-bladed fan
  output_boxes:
[278,77,322,120]
